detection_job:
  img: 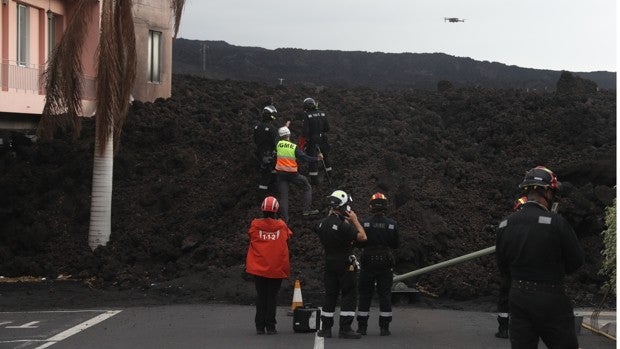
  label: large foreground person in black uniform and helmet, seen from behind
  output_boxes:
[496,166,584,349]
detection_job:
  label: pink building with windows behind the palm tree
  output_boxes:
[0,0,174,130]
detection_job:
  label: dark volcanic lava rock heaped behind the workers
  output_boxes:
[0,76,616,305]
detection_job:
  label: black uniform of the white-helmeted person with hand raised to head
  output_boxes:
[315,215,357,333]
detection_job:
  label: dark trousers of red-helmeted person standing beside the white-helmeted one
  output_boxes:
[357,268,394,328]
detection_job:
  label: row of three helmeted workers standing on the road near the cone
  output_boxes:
[246,190,399,339]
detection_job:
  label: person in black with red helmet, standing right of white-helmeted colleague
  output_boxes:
[357,192,399,336]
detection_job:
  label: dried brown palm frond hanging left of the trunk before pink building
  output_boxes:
[37,0,96,138]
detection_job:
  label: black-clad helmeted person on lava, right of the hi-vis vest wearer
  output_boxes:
[298,98,332,185]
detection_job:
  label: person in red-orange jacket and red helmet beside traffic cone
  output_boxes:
[245,196,293,334]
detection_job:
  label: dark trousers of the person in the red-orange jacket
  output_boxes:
[254,276,282,330]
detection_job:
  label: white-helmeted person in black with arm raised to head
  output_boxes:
[315,190,366,339]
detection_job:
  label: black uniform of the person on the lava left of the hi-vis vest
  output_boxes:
[254,121,278,196]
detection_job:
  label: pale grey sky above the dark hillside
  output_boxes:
[178,0,618,72]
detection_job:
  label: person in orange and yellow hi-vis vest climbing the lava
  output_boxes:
[275,126,323,222]
